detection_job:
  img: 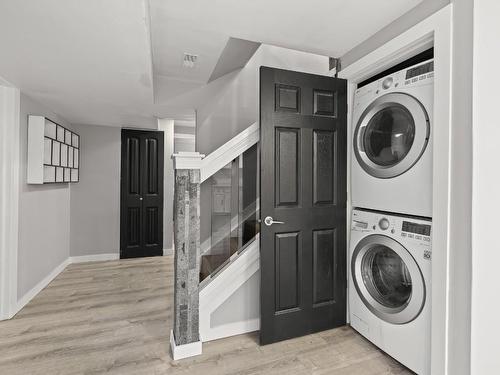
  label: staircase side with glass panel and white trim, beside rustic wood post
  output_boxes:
[194,123,260,342]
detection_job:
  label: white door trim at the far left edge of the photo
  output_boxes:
[0,78,20,320]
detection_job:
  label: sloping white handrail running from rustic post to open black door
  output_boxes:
[200,122,260,182]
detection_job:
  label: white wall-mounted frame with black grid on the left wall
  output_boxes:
[27,115,80,184]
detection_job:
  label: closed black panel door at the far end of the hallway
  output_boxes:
[120,129,164,259]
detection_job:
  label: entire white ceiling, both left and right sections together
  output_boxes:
[0,0,422,127]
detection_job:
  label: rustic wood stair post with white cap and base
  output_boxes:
[170,152,204,359]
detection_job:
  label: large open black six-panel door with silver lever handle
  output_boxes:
[260,67,347,344]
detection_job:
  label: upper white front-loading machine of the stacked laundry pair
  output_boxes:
[351,60,434,217]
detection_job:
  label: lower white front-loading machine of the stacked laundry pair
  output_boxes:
[348,210,431,375]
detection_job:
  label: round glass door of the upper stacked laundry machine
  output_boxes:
[354,93,430,178]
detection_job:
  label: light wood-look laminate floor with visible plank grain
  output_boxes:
[0,257,411,375]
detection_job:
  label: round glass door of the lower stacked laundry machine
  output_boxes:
[351,234,425,324]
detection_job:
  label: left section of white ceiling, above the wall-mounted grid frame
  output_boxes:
[0,0,154,126]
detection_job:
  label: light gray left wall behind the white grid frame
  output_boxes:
[17,93,72,299]
